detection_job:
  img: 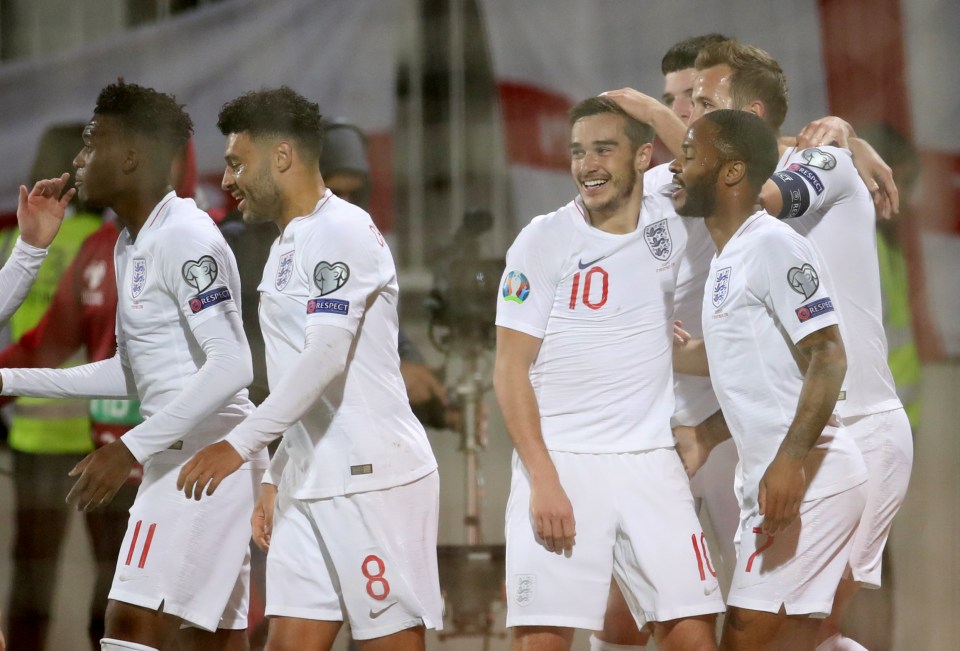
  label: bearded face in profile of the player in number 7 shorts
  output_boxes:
[670,120,722,217]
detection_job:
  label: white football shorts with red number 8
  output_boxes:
[265,470,443,640]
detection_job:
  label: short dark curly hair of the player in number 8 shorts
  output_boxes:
[217,86,323,161]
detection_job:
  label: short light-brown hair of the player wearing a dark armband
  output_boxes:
[696,40,788,129]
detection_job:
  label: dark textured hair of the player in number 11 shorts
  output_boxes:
[93,77,193,152]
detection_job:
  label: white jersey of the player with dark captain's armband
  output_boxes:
[771,147,901,418]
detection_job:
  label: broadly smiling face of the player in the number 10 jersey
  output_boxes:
[570,113,642,220]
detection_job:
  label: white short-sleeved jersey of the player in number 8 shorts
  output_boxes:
[257,190,437,499]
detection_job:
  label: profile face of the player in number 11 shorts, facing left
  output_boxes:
[73,115,127,208]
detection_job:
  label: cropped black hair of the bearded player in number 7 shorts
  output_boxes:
[698,109,780,193]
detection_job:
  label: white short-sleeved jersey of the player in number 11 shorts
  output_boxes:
[114,192,267,460]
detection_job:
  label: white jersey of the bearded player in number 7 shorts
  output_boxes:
[703,211,866,511]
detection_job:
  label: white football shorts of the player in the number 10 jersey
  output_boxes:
[506,448,724,630]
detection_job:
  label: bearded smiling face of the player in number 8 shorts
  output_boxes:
[220,132,282,224]
